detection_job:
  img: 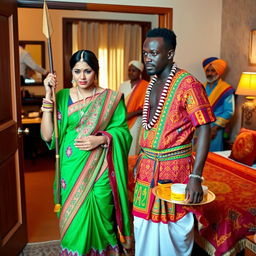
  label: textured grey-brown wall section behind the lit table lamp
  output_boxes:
[221,0,256,140]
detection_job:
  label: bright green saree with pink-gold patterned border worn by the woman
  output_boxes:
[47,89,131,256]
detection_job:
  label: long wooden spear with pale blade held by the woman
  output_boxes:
[43,0,61,212]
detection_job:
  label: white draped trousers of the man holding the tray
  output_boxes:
[134,212,194,256]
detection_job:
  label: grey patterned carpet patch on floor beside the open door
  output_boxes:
[19,240,60,256]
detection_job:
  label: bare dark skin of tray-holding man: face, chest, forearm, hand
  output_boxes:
[143,37,211,203]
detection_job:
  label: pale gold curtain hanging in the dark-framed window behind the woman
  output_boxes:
[72,21,142,90]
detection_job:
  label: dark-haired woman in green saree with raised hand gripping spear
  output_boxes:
[41,50,131,256]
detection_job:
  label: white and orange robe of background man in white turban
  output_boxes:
[119,80,148,156]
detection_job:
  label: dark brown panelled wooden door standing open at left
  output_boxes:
[0,0,27,256]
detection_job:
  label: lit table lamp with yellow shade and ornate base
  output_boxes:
[236,72,256,125]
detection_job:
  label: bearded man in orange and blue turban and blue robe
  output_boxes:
[202,57,234,151]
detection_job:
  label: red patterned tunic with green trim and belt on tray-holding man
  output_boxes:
[133,70,215,223]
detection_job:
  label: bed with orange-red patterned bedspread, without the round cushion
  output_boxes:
[190,151,256,256]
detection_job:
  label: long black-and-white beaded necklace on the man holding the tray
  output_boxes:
[142,63,177,130]
